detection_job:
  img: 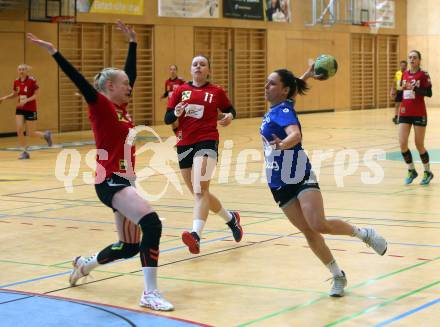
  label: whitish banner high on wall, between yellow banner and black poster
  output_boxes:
[157,0,219,18]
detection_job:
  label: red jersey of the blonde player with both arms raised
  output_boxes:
[88,93,136,182]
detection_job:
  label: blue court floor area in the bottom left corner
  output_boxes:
[0,290,202,327]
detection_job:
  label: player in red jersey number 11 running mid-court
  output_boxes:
[165,55,243,254]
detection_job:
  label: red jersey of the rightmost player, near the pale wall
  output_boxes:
[400,70,431,117]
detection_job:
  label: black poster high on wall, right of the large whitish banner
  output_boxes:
[223,0,264,20]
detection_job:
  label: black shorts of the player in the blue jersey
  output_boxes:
[270,171,320,208]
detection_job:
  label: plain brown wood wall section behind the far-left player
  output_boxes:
[0,13,58,133]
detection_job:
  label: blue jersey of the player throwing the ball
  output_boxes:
[260,100,312,189]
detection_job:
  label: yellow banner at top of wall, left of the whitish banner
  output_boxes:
[90,0,144,15]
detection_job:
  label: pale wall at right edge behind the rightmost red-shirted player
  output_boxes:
[407,0,440,106]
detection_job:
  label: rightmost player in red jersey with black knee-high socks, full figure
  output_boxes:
[399,50,434,185]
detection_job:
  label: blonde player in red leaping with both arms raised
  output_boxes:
[28,21,174,311]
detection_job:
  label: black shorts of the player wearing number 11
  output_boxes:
[177,141,218,169]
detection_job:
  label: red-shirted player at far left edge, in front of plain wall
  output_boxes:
[0,64,52,159]
